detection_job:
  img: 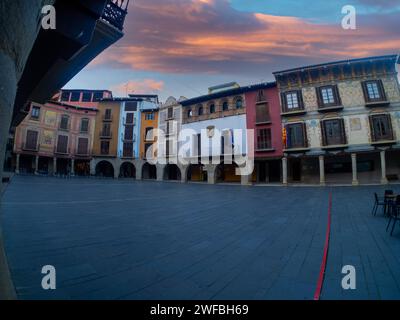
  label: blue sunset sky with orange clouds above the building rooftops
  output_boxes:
[66,0,400,101]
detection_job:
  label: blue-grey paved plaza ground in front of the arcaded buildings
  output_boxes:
[0,176,400,299]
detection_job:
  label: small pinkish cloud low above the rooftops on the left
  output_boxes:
[110,79,164,96]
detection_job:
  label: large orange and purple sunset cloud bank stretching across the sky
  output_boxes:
[92,0,400,74]
